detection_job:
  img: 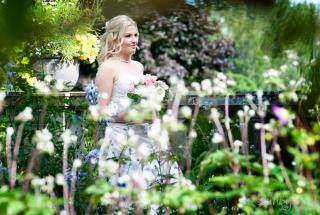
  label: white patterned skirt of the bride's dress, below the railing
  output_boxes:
[99,122,181,188]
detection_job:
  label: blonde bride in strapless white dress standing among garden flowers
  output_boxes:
[95,15,180,212]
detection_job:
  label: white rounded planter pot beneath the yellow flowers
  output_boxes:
[34,58,79,91]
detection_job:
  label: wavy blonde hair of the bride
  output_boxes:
[98,15,138,64]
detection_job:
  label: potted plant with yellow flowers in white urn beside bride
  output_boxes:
[11,0,101,90]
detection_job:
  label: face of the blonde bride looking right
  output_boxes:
[121,25,139,54]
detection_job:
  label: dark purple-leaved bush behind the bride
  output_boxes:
[138,8,234,83]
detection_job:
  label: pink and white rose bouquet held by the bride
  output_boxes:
[127,74,169,104]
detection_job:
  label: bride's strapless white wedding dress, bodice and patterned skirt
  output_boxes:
[99,75,181,189]
